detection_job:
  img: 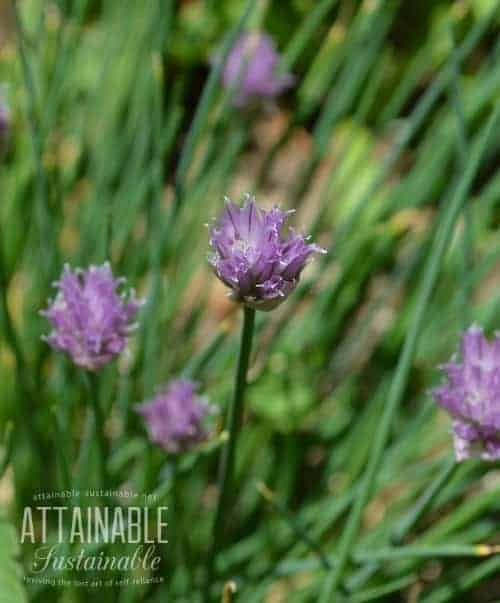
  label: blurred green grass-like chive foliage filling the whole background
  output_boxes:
[0,0,500,603]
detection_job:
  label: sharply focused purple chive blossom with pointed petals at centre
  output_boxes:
[209,195,326,311]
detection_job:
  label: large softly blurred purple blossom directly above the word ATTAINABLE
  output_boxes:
[42,262,143,371]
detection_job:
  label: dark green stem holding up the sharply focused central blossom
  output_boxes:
[204,307,255,603]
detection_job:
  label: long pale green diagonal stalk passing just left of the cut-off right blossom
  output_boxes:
[320,104,500,603]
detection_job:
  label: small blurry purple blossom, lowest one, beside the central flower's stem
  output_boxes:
[135,379,211,453]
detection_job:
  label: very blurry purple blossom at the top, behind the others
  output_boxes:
[222,32,295,107]
